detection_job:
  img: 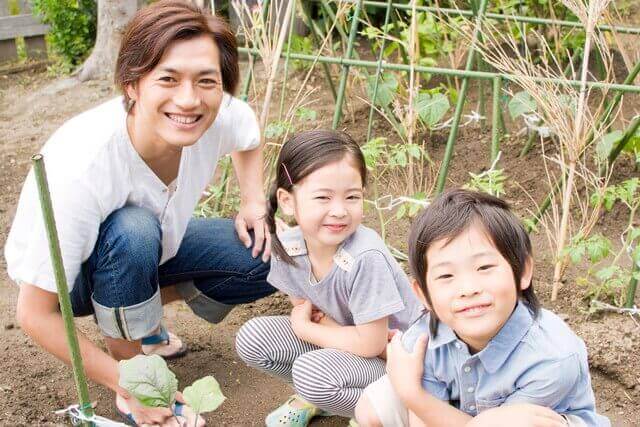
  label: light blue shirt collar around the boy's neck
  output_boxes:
[436,301,533,374]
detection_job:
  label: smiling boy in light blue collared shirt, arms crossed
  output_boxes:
[356,190,609,427]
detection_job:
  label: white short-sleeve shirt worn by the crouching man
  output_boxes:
[5,94,260,292]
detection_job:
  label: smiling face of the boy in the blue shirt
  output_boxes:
[419,222,533,352]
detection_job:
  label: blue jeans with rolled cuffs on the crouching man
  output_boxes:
[71,206,275,340]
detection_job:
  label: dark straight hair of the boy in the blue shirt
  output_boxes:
[409,189,540,336]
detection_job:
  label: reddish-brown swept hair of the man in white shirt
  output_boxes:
[115,0,240,105]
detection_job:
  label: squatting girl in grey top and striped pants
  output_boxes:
[236,130,421,426]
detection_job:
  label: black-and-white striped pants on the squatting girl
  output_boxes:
[236,316,385,417]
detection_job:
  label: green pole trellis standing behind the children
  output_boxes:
[239,0,640,207]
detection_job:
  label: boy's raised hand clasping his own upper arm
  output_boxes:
[387,332,428,400]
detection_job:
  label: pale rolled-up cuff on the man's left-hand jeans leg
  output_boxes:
[91,289,162,341]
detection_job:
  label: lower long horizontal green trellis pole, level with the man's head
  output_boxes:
[238,47,640,93]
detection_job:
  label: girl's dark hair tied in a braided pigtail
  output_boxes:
[266,129,367,265]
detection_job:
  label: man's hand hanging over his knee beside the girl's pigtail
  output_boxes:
[235,202,271,262]
